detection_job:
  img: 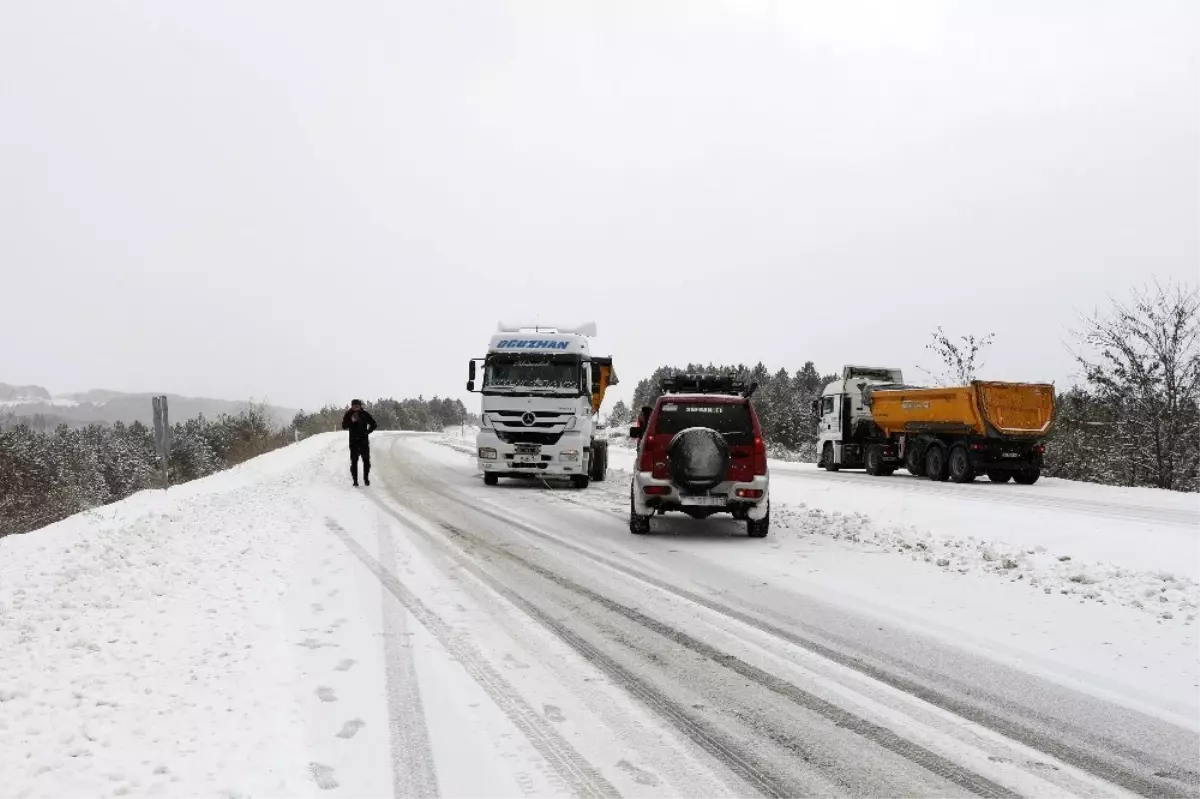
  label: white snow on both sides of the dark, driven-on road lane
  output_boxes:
[0,428,1200,799]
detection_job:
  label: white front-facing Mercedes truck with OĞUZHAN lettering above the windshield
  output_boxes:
[467,323,617,488]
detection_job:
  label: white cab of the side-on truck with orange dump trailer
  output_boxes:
[814,366,904,470]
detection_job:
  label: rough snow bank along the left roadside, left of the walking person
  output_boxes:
[0,434,342,797]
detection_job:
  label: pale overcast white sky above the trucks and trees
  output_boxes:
[0,0,1200,408]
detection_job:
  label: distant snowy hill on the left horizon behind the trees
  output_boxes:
[0,383,296,429]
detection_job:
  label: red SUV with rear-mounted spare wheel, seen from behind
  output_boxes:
[629,374,770,539]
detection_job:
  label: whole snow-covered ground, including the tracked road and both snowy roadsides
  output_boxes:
[0,434,1200,799]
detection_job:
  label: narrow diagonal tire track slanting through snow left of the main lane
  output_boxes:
[325,518,620,799]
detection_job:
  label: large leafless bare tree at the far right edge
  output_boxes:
[1074,283,1200,491]
